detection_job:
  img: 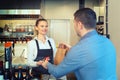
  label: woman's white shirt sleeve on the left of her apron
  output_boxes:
[27,40,37,67]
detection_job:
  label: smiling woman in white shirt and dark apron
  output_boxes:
[28,19,66,80]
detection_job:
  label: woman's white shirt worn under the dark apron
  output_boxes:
[27,36,56,67]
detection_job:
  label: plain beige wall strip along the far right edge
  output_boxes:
[108,0,120,80]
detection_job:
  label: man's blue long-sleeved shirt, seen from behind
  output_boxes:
[47,30,117,80]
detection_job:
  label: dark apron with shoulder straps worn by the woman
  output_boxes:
[32,39,53,77]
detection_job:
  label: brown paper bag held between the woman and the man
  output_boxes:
[54,46,68,65]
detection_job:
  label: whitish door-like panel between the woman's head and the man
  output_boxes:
[49,19,70,46]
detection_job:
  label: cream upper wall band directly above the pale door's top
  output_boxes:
[44,0,79,19]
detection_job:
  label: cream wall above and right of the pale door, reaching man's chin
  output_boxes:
[41,0,79,45]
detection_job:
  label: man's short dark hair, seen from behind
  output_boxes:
[74,8,96,29]
